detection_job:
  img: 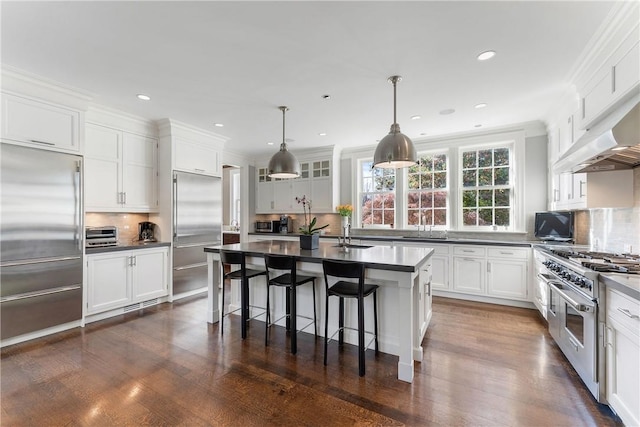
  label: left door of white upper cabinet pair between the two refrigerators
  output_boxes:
[84,124,122,212]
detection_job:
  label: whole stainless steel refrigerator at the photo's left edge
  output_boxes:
[0,143,83,340]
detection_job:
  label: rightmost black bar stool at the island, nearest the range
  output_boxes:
[322,260,378,377]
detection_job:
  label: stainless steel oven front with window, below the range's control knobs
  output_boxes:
[549,281,599,399]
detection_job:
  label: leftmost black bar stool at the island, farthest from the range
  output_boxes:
[220,251,267,339]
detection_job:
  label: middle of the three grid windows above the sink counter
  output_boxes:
[407,154,449,227]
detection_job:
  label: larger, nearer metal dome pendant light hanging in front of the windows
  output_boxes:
[373,76,418,169]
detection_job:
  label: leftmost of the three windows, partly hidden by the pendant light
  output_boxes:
[360,161,396,226]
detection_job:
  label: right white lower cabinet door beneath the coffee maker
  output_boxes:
[132,249,169,302]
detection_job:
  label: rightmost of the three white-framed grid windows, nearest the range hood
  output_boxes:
[461,147,513,227]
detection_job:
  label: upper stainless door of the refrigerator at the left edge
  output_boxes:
[0,143,83,263]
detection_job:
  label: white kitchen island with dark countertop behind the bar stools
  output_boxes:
[204,240,433,382]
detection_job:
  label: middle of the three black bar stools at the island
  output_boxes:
[264,254,318,354]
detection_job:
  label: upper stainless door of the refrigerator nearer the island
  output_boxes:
[173,172,222,246]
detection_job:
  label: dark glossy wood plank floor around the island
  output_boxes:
[0,298,618,426]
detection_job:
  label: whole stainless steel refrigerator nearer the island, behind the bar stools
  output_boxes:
[173,172,222,296]
